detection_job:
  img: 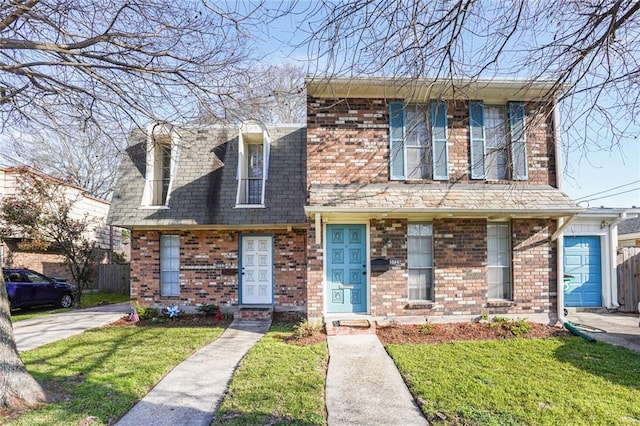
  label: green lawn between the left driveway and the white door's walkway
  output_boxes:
[10,326,224,426]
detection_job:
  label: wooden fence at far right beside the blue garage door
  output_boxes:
[618,247,640,312]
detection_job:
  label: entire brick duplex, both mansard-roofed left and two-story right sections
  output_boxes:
[109,79,581,322]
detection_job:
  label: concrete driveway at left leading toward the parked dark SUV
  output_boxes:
[13,302,131,352]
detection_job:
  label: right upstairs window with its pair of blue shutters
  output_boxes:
[469,102,528,180]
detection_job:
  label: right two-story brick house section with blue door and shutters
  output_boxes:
[305,79,581,322]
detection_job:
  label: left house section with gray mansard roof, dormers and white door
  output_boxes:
[108,122,307,311]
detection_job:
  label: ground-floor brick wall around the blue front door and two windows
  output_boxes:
[307,219,557,318]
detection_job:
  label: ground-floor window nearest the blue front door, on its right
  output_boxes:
[407,223,433,301]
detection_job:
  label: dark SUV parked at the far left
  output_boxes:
[2,268,73,309]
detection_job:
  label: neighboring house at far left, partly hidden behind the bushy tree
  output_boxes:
[0,167,120,279]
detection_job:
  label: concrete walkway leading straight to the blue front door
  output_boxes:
[326,334,428,426]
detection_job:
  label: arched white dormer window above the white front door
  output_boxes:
[236,121,270,208]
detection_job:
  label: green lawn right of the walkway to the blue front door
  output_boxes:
[387,337,640,425]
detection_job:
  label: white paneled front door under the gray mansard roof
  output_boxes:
[240,236,273,305]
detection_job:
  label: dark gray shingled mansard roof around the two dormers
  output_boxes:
[107,126,306,227]
